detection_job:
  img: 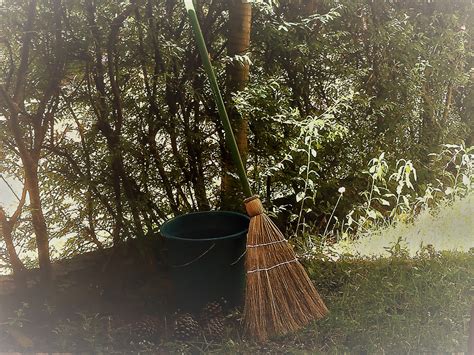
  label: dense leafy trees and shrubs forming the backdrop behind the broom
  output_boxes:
[0,0,473,268]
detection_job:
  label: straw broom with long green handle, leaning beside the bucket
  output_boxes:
[184,0,328,341]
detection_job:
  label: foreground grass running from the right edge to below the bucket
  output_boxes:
[4,249,474,354]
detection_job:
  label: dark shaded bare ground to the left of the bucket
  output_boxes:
[0,240,178,351]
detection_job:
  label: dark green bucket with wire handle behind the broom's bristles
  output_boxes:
[160,211,249,311]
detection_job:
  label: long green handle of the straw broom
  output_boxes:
[184,0,253,197]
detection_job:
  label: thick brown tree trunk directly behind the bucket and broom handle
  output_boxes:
[221,0,252,209]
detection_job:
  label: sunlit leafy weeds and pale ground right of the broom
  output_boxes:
[291,143,474,258]
